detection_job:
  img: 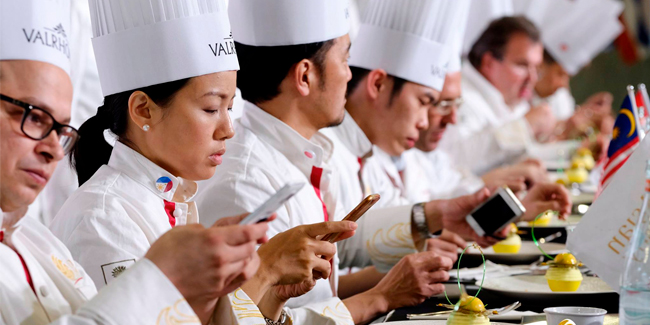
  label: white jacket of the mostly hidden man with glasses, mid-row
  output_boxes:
[402,149,485,202]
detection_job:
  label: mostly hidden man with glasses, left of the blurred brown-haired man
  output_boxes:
[398,45,571,220]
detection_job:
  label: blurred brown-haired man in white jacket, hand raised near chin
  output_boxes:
[440,17,555,175]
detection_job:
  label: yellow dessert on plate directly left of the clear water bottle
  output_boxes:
[546,253,582,292]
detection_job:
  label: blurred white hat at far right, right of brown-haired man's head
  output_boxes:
[516,0,624,75]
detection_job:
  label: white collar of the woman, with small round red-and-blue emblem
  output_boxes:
[108,141,198,202]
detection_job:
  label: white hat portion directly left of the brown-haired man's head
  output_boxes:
[463,0,519,54]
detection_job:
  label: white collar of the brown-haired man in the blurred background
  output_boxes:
[462,62,529,120]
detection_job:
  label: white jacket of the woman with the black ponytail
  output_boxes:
[50,142,198,288]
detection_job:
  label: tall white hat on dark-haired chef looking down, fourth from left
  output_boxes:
[350,0,463,90]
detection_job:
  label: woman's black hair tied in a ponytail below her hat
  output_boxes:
[70,78,190,186]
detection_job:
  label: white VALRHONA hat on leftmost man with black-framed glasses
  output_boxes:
[0,0,70,74]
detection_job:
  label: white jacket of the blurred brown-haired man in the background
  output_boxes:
[438,62,533,175]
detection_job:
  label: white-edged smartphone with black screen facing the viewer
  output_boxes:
[466,186,526,236]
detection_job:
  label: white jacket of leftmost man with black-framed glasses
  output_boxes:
[0,211,198,324]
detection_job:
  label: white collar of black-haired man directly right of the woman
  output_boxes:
[239,101,334,176]
